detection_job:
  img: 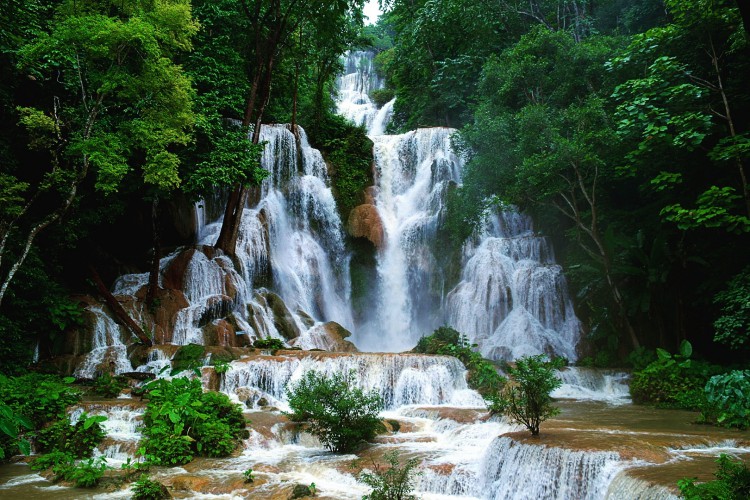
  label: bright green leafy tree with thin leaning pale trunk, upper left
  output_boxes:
[0,0,197,314]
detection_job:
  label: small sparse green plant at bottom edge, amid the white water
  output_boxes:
[357,450,422,500]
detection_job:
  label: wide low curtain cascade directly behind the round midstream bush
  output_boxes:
[221,354,484,409]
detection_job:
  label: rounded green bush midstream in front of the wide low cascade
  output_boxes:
[286,371,383,453]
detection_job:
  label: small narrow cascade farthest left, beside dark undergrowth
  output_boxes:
[73,306,133,378]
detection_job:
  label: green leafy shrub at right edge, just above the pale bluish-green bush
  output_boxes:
[714,267,750,350]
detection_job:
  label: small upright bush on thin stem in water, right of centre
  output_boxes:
[490,355,562,436]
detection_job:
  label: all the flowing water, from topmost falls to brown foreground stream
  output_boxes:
[0,52,750,500]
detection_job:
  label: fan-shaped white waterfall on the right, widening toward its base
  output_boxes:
[446,211,580,361]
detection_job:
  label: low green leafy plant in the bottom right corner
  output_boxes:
[677,453,750,500]
